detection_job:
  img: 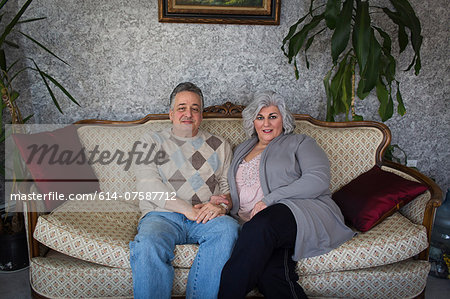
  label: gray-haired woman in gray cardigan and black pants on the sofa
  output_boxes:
[219,91,354,299]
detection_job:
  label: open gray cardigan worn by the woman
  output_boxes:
[228,134,355,261]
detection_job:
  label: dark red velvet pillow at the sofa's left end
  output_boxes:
[12,125,100,209]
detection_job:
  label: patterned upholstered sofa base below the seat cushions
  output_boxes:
[30,251,430,298]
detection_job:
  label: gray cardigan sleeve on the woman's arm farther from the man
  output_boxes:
[263,137,330,206]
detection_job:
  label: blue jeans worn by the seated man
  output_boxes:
[130,212,239,299]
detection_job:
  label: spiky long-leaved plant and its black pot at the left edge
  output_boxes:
[0,0,79,270]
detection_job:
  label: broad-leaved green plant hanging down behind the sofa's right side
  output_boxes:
[282,0,422,121]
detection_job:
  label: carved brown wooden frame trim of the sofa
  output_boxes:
[21,102,443,298]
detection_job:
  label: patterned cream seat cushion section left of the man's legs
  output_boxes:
[33,199,141,268]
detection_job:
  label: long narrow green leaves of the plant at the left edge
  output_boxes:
[0,0,80,233]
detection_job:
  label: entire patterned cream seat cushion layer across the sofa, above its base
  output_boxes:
[34,200,428,274]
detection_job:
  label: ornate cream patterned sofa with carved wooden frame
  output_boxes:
[25,103,442,298]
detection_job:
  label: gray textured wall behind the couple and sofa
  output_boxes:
[7,0,450,192]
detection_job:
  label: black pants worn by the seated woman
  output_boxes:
[219,204,307,299]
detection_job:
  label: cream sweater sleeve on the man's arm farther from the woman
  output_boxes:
[134,134,174,208]
